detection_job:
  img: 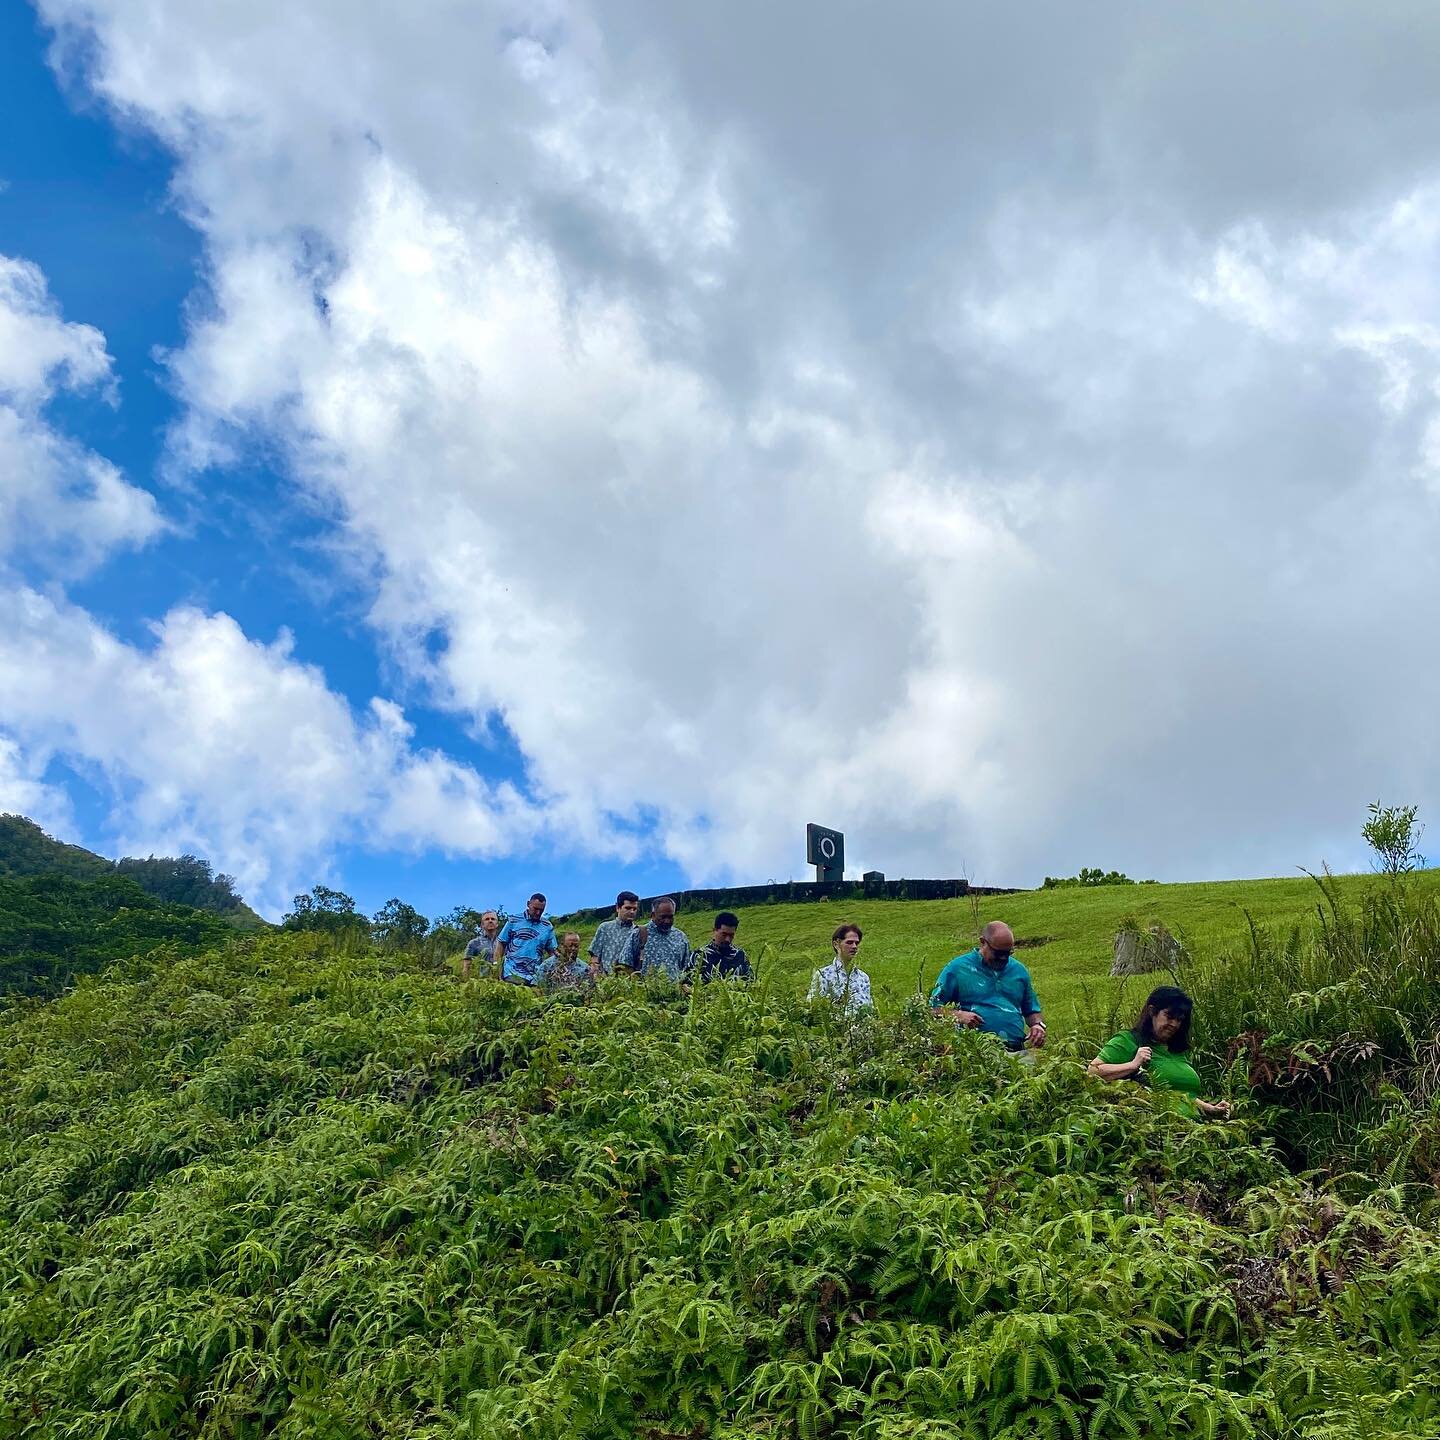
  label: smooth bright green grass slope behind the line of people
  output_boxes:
[610,870,1440,1034]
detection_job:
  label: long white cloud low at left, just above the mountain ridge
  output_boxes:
[0,588,547,914]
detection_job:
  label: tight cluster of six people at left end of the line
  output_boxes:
[461,890,755,986]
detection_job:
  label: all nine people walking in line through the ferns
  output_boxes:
[461,890,1230,1117]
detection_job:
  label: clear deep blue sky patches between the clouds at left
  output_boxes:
[0,6,696,914]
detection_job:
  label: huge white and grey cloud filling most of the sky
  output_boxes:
[30,0,1440,883]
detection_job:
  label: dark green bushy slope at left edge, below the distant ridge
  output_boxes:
[0,873,235,995]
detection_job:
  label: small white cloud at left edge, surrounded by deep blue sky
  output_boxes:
[0,255,163,567]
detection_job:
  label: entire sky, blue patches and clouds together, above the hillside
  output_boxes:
[0,0,1440,914]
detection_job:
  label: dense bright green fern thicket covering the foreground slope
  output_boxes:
[0,935,1440,1440]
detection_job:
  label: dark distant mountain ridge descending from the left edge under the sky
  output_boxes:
[0,815,265,930]
